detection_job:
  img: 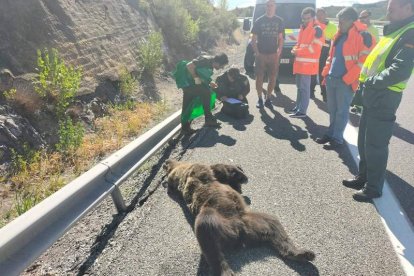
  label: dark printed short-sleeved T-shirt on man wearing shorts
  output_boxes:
[252,15,285,54]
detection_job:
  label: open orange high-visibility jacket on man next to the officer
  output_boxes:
[322,21,375,91]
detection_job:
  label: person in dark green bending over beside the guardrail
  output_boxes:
[174,53,229,134]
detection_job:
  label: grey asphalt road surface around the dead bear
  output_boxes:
[80,75,414,275]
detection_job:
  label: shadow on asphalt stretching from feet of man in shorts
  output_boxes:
[260,109,308,151]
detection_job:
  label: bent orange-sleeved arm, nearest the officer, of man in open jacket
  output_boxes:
[342,32,375,85]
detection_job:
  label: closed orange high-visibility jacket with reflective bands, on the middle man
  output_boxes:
[293,20,325,75]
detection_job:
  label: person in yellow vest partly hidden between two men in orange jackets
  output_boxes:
[310,8,338,102]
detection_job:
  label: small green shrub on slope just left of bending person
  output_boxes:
[138,32,164,75]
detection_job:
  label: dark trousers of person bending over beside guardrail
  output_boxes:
[181,84,213,128]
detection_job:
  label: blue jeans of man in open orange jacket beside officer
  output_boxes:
[326,76,354,144]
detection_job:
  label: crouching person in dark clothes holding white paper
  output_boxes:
[216,68,250,119]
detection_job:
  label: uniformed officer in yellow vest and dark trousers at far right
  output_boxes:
[343,0,414,201]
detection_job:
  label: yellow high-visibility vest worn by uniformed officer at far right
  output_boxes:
[359,22,414,92]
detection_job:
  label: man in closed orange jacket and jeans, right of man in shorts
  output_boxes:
[289,8,325,118]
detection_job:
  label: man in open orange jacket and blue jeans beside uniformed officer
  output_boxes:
[316,7,374,149]
